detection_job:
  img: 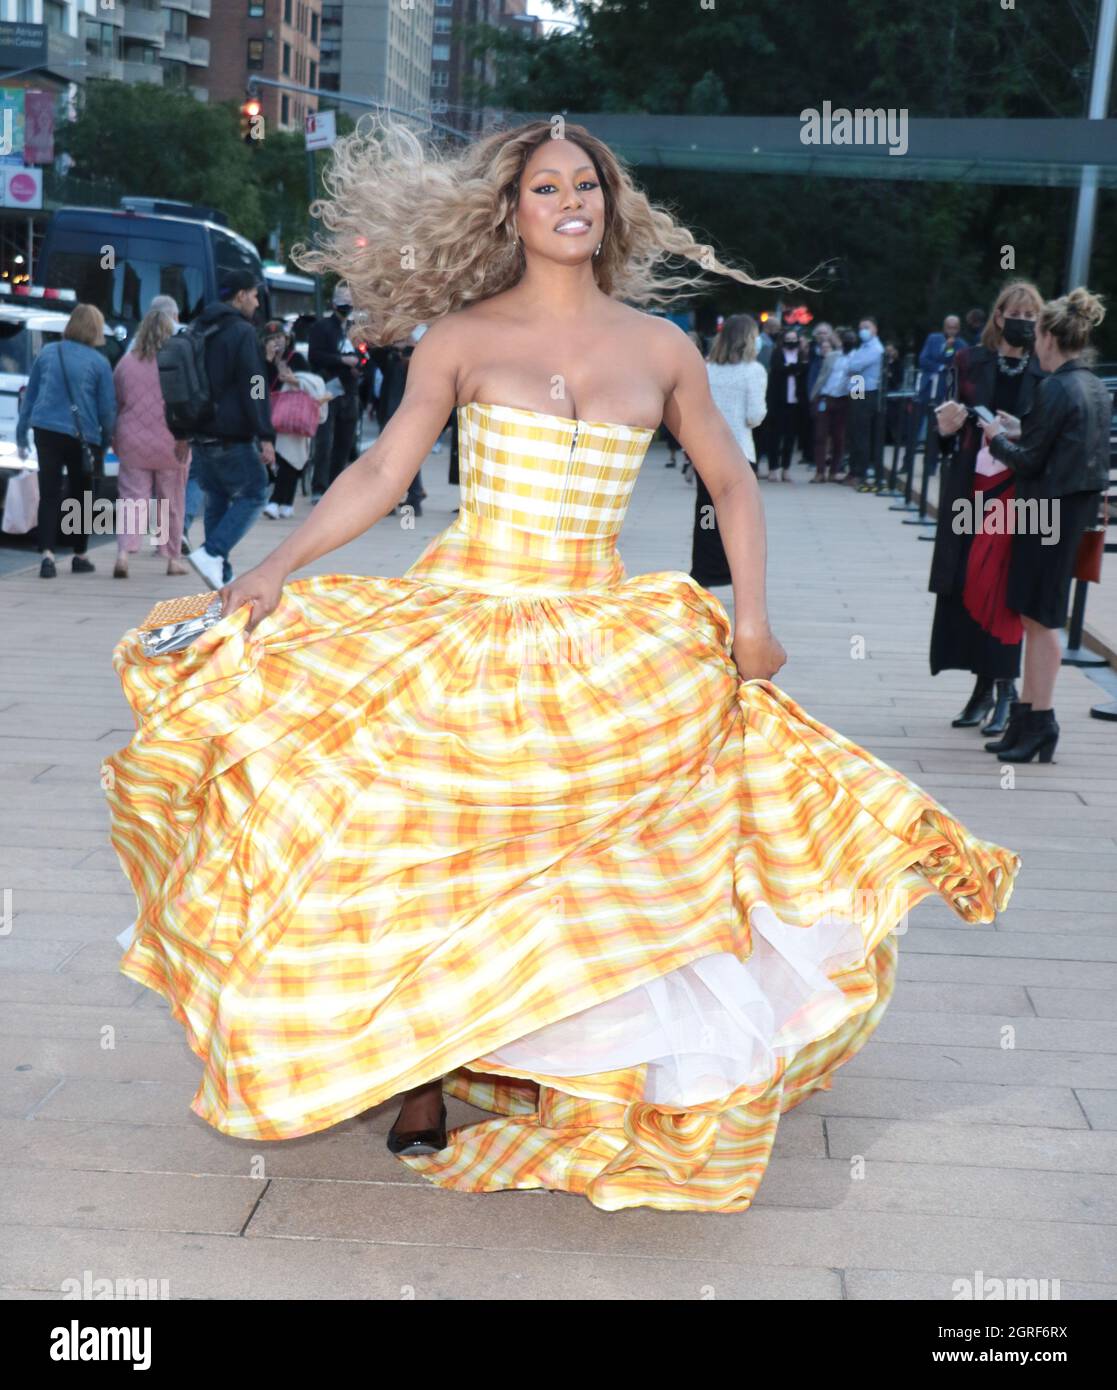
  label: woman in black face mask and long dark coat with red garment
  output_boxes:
[928,281,1046,738]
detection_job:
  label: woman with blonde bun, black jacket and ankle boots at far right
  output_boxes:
[982,286,1113,763]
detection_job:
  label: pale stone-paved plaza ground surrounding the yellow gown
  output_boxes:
[0,436,1117,1300]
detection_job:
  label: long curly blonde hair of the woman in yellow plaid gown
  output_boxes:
[292,114,809,343]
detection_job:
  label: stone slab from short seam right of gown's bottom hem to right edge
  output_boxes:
[827,1116,1117,1173]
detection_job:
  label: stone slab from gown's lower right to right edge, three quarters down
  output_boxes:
[839,1038,1117,1090]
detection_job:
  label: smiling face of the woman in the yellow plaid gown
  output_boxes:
[515,140,606,265]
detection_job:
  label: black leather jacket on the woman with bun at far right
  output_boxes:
[989,359,1113,498]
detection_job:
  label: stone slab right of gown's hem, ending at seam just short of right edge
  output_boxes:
[803,1063,1086,1129]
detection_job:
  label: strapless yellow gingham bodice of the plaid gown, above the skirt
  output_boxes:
[407,400,656,594]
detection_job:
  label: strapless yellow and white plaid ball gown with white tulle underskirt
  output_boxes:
[106,402,1020,1212]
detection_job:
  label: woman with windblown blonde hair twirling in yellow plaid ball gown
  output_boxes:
[107,122,1018,1212]
